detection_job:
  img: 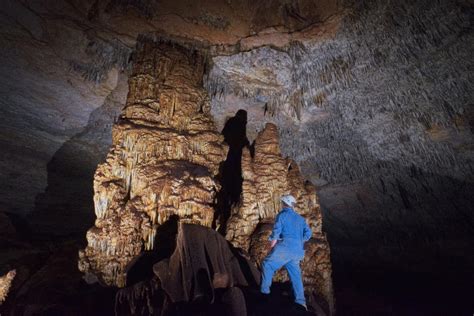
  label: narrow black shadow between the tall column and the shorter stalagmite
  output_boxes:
[213,110,249,233]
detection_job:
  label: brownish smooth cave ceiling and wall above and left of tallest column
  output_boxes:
[0,0,339,222]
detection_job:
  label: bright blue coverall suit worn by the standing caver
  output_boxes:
[260,207,312,305]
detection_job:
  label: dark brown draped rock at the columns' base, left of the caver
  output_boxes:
[153,224,260,303]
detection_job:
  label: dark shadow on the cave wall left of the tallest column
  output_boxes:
[28,94,121,238]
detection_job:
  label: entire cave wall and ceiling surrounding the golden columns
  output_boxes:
[0,0,474,314]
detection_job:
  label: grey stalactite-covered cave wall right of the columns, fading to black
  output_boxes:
[207,1,474,314]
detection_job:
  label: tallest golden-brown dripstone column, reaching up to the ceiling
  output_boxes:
[79,40,227,287]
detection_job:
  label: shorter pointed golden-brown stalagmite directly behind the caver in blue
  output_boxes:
[226,124,334,312]
